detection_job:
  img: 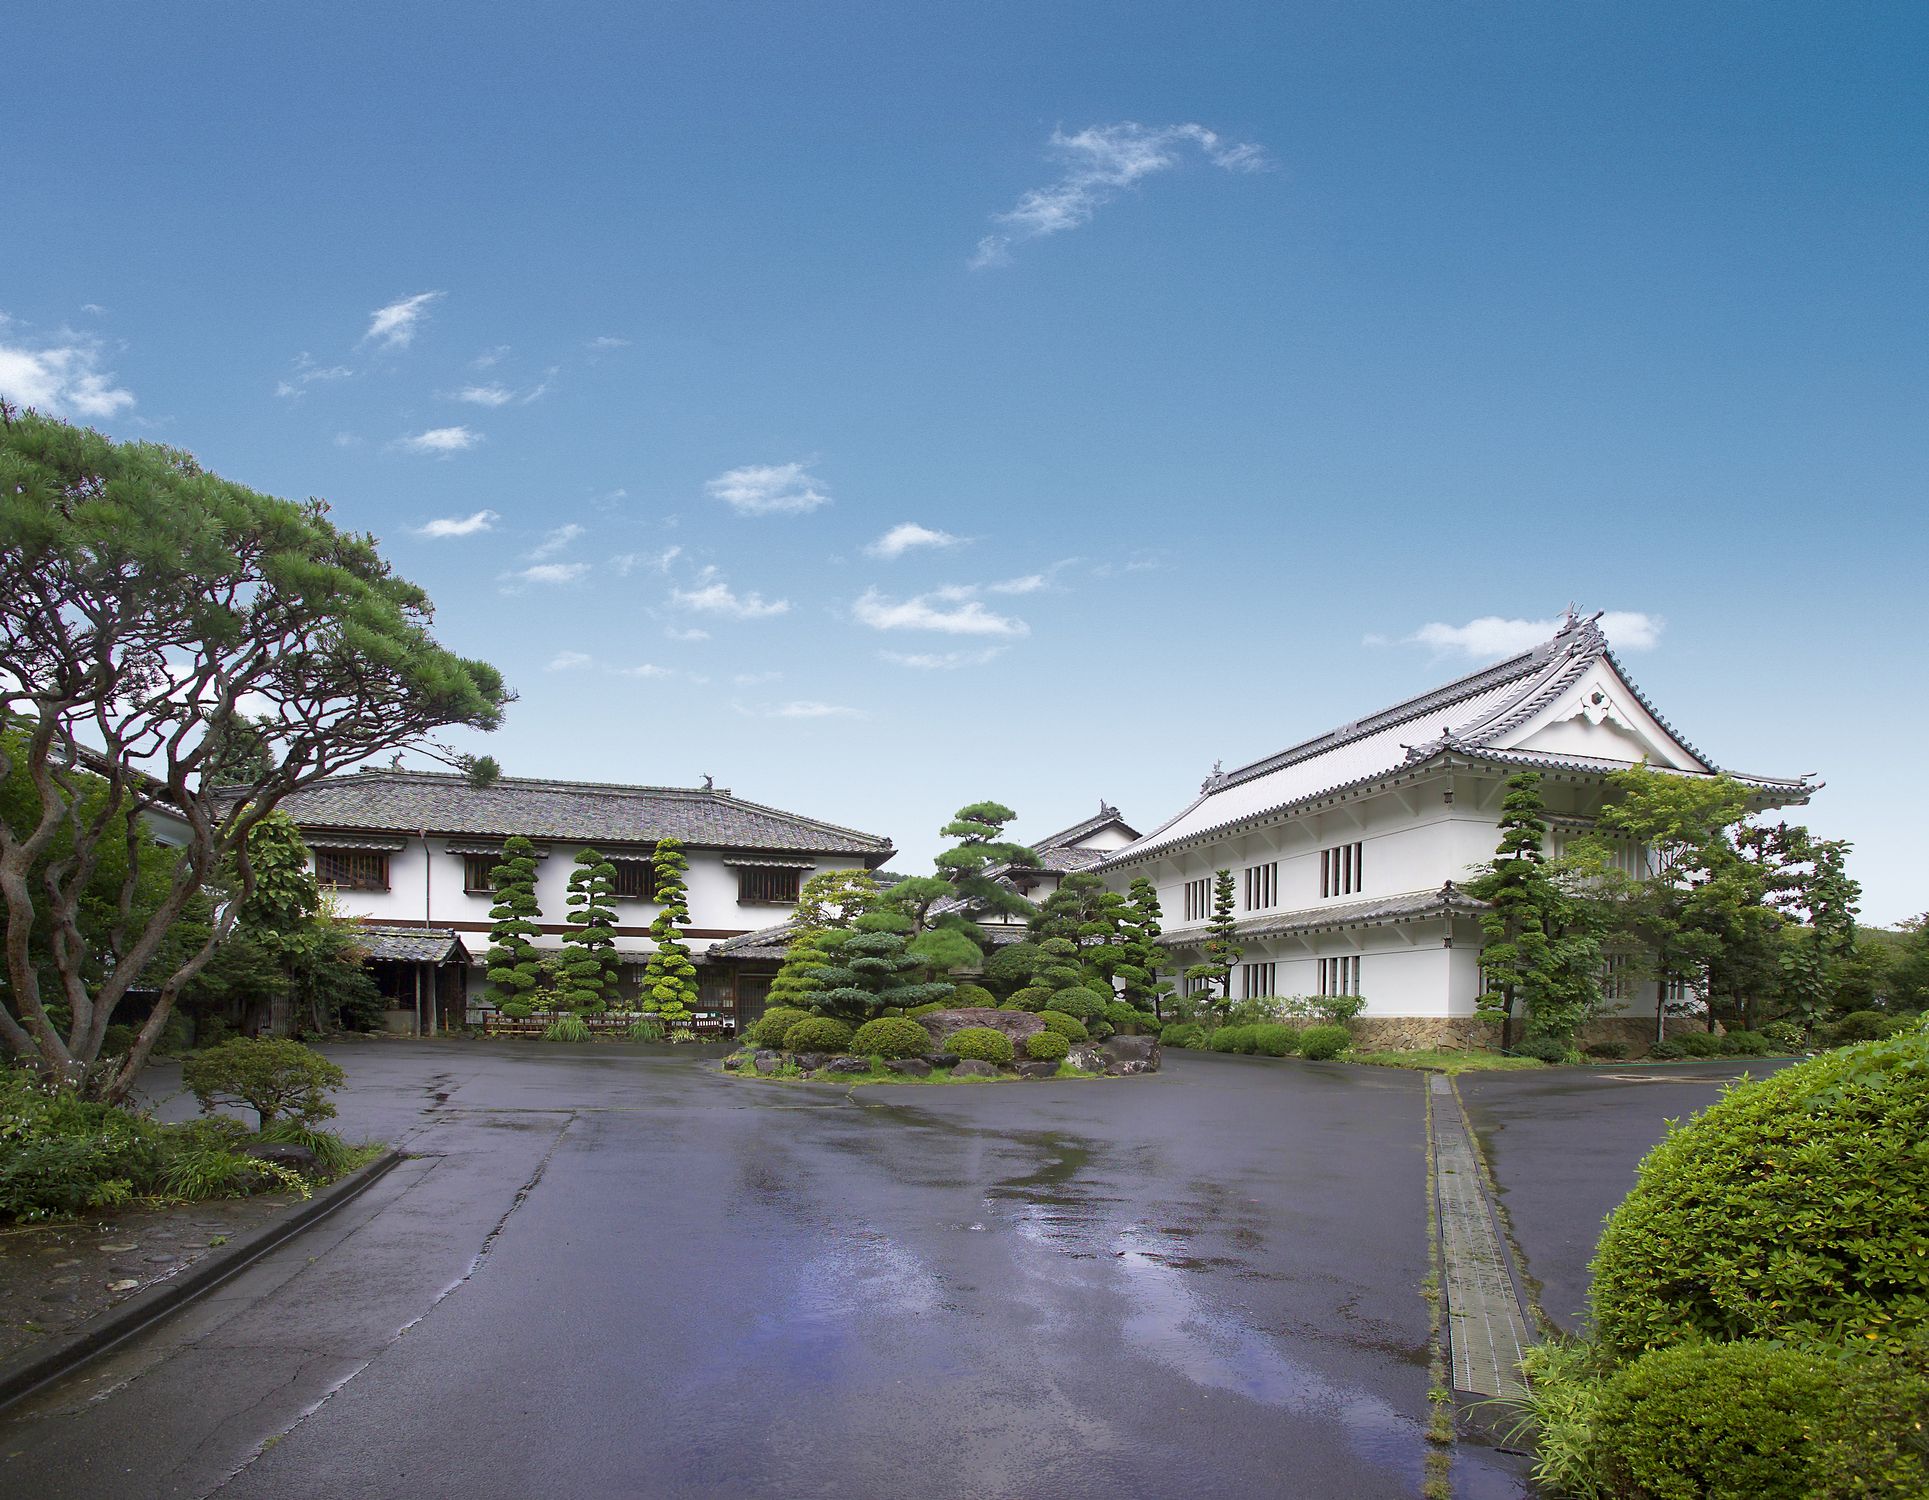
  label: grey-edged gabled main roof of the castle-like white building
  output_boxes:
[1105,613,1815,866]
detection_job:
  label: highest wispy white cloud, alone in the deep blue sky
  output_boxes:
[970,120,1267,270]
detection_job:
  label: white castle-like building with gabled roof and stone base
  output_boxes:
[1100,613,1815,1045]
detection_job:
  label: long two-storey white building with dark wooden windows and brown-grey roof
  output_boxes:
[268,767,893,1033]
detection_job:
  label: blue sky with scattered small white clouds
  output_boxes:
[0,4,1929,922]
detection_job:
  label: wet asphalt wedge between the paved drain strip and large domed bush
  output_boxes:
[1456,1058,1790,1332]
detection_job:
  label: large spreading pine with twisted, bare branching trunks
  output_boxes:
[0,403,511,1099]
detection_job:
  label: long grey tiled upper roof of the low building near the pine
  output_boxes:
[252,769,893,866]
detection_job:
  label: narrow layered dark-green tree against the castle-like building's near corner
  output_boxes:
[1468,771,1601,1047]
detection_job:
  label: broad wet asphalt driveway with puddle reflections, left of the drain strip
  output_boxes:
[0,1043,1481,1500]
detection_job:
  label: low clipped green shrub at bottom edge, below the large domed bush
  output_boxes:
[1591,1342,1844,1500]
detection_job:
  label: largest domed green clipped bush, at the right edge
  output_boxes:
[1591,1033,1929,1357]
